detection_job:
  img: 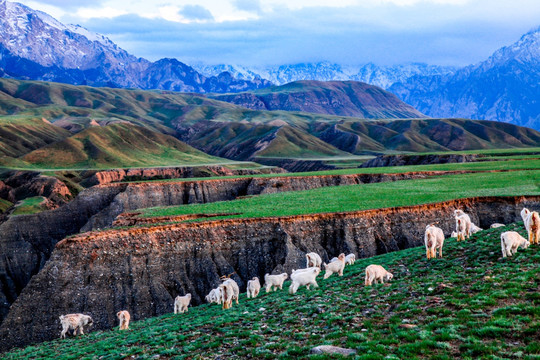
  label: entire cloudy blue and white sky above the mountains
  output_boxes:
[14,0,540,66]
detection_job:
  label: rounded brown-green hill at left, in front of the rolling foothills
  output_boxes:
[17,123,228,168]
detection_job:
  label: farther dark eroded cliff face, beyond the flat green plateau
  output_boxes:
[0,172,441,328]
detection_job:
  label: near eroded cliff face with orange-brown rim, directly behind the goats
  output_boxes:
[0,196,540,350]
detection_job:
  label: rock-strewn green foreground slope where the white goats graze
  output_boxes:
[4,224,540,359]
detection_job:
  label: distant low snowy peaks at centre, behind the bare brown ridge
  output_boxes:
[193,62,456,89]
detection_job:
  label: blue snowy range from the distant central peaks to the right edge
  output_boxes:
[194,28,540,130]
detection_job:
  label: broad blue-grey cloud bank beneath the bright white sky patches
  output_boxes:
[61,0,540,66]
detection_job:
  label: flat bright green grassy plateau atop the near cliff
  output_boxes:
[139,170,540,218]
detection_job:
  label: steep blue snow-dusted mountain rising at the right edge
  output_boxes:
[389,28,540,130]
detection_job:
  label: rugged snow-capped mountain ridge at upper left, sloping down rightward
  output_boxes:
[0,0,270,92]
